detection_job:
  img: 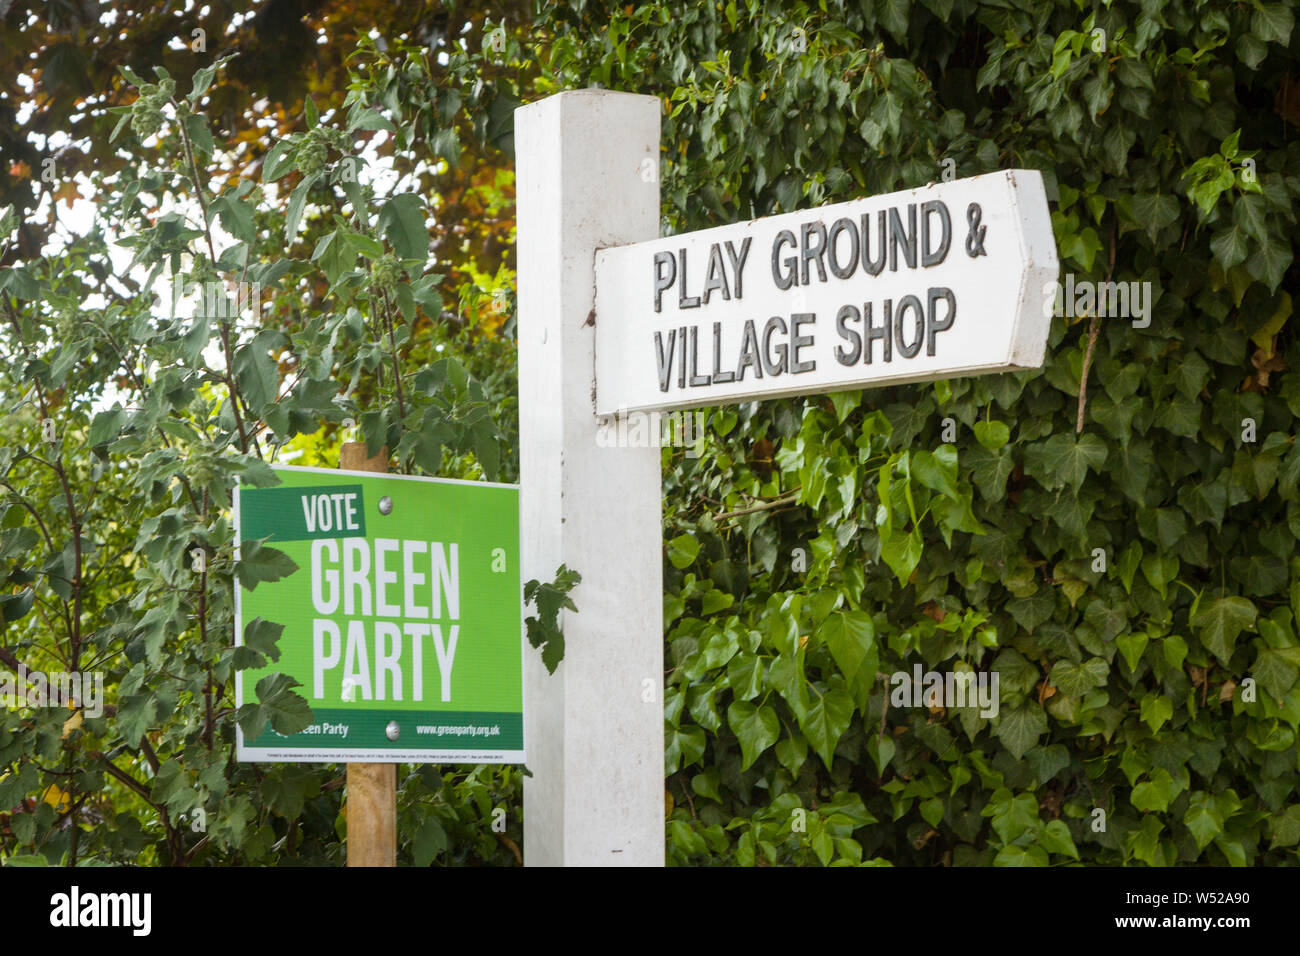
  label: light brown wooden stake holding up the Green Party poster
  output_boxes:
[338,441,398,866]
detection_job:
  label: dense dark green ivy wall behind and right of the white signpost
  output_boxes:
[542,0,1300,866]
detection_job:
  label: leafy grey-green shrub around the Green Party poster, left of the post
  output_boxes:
[0,31,520,865]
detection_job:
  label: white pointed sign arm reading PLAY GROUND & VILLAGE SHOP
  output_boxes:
[595,169,1058,415]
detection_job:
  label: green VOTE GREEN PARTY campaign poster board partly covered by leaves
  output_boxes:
[234,466,524,763]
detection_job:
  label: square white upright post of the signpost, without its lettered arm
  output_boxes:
[515,90,664,866]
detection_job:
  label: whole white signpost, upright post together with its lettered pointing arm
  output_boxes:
[515,90,1058,865]
